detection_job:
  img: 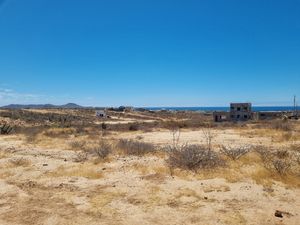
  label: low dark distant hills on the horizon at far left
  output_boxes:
[0,103,85,109]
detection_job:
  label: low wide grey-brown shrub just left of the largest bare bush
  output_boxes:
[118,139,156,156]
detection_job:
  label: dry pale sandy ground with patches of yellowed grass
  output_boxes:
[0,110,300,225]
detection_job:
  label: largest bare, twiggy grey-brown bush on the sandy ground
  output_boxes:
[167,145,224,171]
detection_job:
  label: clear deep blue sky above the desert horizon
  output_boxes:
[0,0,300,106]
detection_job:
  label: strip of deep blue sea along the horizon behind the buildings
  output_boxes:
[146,106,299,112]
